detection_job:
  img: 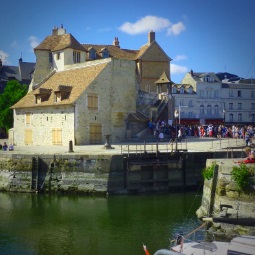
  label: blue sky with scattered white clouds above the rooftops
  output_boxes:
[0,0,255,83]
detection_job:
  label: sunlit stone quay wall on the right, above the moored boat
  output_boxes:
[197,159,255,236]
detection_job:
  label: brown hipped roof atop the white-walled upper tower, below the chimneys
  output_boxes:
[34,34,85,51]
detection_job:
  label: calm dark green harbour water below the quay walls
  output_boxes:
[0,192,201,255]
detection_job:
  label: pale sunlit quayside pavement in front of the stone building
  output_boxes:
[0,137,245,157]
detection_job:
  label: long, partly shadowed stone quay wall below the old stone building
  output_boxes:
[0,152,219,194]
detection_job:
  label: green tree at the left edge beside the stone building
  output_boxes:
[0,80,28,130]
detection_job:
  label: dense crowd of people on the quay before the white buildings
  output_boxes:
[148,119,255,146]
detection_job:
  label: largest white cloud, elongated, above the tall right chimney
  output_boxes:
[119,16,171,35]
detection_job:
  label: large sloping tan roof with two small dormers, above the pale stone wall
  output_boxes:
[12,61,109,109]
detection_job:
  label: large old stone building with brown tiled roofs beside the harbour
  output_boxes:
[10,26,171,145]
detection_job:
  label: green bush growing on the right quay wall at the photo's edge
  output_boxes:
[231,163,254,190]
